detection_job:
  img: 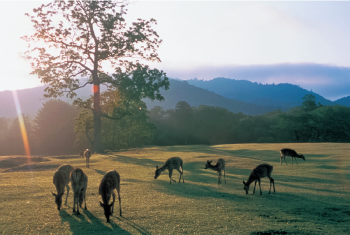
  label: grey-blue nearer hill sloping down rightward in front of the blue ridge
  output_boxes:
[143,79,282,115]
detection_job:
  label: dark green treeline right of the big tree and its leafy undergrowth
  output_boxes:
[149,94,350,145]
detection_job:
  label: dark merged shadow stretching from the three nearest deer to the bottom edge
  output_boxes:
[59,210,130,234]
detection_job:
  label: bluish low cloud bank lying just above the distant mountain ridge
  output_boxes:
[166,64,350,101]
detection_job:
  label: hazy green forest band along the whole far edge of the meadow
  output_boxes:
[0,91,350,155]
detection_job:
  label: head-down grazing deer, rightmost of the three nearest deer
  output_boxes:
[98,171,122,223]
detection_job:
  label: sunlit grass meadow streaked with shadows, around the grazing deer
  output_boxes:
[0,143,350,235]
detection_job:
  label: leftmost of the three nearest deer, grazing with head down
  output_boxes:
[51,165,73,210]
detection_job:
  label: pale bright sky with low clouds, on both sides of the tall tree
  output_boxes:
[0,0,350,100]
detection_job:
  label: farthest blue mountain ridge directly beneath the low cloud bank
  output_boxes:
[187,78,334,109]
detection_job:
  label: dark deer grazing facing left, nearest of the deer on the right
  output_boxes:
[243,164,275,195]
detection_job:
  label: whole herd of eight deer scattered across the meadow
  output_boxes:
[51,148,305,222]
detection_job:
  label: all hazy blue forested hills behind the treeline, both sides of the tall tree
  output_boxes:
[0,78,350,118]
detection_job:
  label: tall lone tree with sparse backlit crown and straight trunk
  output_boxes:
[23,0,169,152]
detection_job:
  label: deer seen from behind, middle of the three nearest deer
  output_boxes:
[70,168,88,215]
